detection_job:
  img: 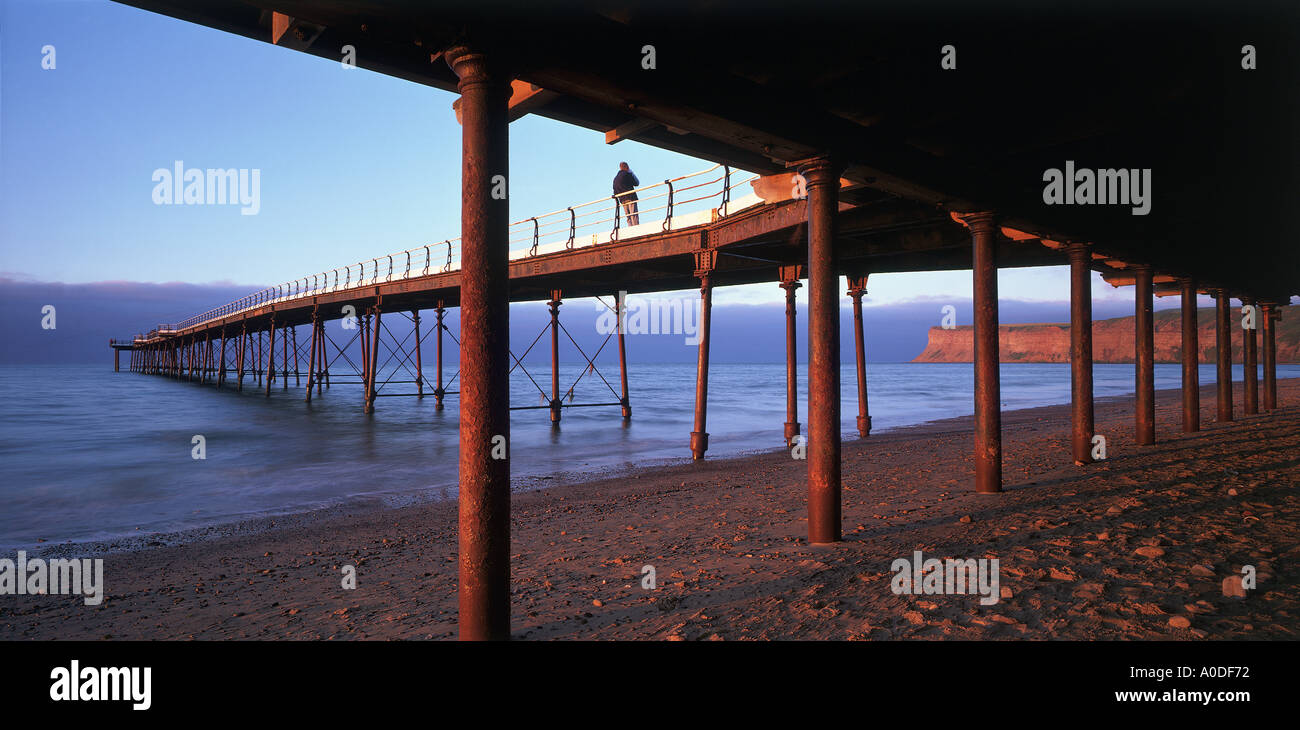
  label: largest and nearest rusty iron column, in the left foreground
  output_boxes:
[445,45,511,640]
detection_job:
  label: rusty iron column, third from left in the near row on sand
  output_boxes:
[962,212,1002,494]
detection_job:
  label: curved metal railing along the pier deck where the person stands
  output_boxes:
[154,165,762,339]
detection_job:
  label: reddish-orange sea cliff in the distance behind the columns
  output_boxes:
[913,307,1300,362]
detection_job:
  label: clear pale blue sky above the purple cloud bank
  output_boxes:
[0,0,1209,308]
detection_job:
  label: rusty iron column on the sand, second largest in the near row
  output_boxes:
[800,157,841,543]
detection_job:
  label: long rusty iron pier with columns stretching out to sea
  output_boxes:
[111,0,1300,639]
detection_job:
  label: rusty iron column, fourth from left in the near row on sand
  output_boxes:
[1066,243,1096,466]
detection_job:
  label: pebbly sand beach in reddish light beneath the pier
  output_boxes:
[0,381,1300,640]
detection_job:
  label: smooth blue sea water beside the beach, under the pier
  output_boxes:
[0,359,1300,548]
